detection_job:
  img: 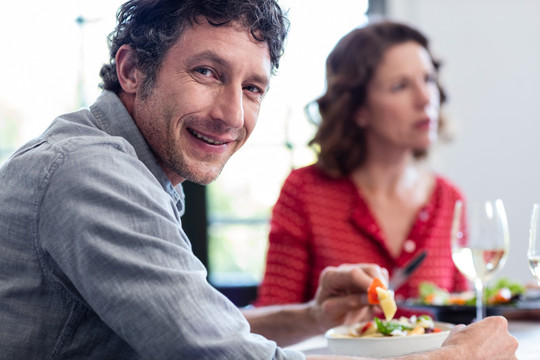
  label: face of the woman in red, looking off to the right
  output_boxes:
[357,41,440,155]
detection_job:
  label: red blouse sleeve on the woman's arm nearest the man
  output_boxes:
[255,171,310,306]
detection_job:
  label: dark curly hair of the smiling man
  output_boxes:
[100,0,289,97]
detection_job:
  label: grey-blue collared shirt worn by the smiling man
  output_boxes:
[0,91,304,360]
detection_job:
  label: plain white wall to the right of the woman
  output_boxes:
[387,0,540,282]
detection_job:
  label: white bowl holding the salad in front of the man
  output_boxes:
[325,322,454,358]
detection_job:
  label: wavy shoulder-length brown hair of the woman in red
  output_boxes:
[308,21,446,177]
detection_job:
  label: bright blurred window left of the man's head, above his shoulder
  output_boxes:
[0,0,123,164]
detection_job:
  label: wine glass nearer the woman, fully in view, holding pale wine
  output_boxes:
[451,199,510,321]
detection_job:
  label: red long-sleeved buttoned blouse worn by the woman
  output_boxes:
[255,165,469,306]
